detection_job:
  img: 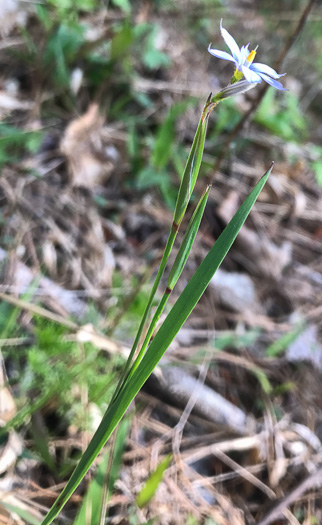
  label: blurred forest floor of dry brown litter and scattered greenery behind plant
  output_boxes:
[0,0,322,525]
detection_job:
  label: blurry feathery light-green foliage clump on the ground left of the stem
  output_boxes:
[3,317,115,428]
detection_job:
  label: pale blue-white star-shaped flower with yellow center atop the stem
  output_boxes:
[208,20,287,91]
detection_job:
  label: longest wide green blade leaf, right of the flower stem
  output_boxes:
[42,166,272,525]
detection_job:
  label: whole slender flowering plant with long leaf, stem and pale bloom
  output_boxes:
[42,23,284,525]
